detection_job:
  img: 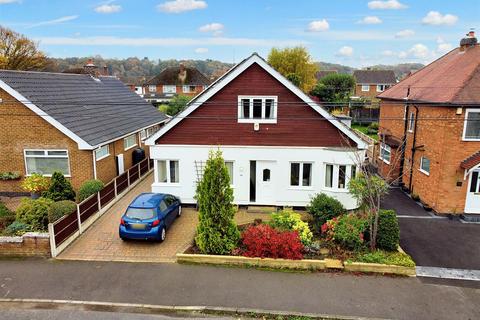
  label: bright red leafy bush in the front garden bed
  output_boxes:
[242,224,303,260]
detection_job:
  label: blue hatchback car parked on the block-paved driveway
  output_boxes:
[119,193,182,241]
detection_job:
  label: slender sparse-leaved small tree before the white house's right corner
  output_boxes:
[348,169,389,250]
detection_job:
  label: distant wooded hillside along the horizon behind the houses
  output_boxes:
[46,56,423,83]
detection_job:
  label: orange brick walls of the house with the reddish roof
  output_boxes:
[380,101,480,213]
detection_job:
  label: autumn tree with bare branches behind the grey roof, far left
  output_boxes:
[0,26,48,70]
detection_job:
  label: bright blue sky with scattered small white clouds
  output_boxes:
[0,0,480,67]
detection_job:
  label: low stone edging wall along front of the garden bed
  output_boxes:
[177,253,416,277]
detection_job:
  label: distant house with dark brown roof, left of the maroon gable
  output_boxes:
[142,64,210,103]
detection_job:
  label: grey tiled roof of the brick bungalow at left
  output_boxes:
[0,70,167,146]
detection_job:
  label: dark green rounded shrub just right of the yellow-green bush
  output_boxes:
[307,193,347,230]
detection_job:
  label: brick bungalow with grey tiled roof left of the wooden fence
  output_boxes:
[0,66,167,193]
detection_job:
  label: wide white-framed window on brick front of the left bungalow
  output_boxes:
[24,150,70,176]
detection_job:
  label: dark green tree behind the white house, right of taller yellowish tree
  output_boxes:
[311,73,355,102]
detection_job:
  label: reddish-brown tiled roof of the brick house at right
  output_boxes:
[377,45,480,105]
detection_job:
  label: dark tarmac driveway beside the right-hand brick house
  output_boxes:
[382,189,480,270]
